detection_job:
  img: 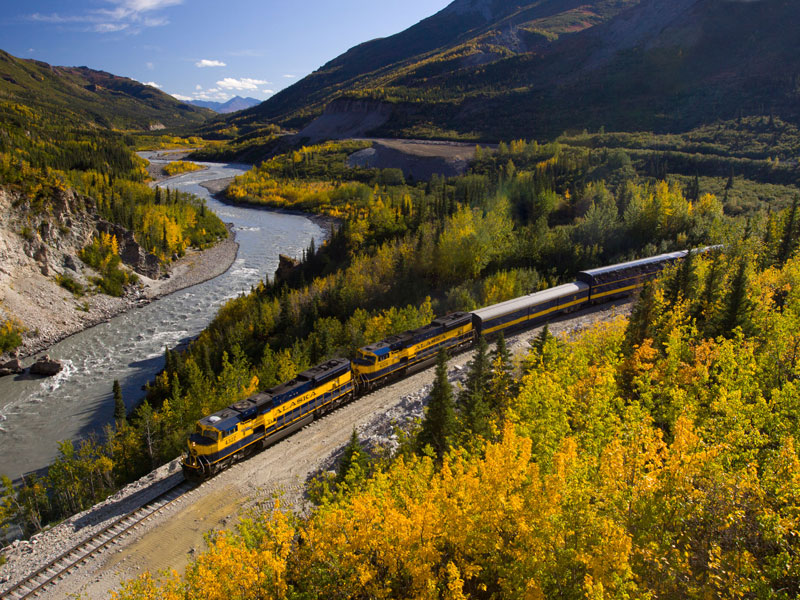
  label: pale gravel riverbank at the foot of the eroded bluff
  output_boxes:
[8,225,239,358]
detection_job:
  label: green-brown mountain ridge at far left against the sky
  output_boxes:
[0,50,213,130]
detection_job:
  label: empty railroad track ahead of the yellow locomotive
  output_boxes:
[0,481,195,600]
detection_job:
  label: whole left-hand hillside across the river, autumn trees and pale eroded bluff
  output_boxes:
[0,51,227,353]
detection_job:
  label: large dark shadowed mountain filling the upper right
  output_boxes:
[243,0,800,139]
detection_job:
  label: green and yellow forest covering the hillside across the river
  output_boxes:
[0,101,228,304]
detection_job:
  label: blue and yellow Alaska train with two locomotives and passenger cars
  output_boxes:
[182,246,717,480]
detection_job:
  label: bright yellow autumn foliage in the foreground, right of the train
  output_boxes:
[111,255,800,600]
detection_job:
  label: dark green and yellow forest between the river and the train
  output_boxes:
[1,125,795,533]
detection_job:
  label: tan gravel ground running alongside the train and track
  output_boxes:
[0,301,631,599]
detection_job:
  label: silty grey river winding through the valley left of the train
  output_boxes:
[0,153,324,479]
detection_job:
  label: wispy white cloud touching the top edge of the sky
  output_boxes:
[29,0,184,33]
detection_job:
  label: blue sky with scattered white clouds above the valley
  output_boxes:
[0,0,450,101]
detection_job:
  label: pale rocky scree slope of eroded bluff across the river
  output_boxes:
[0,187,161,355]
